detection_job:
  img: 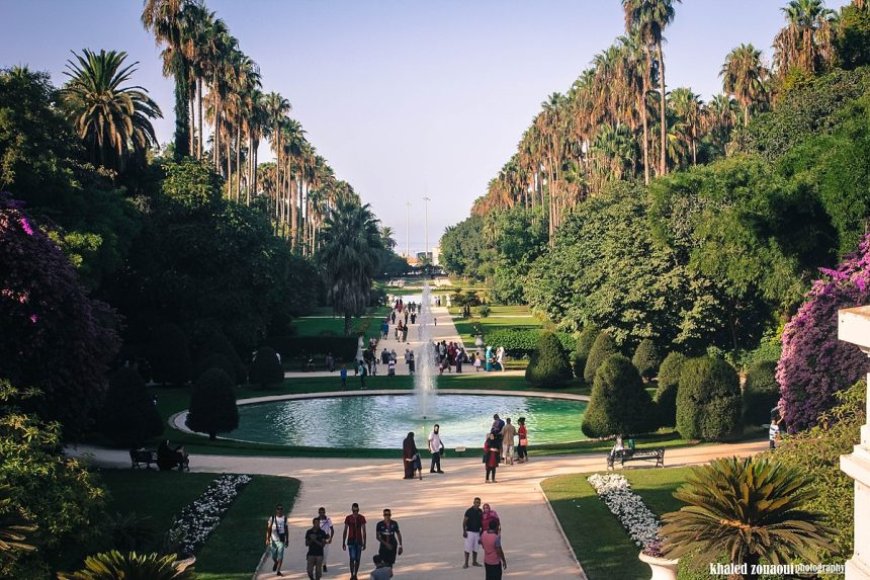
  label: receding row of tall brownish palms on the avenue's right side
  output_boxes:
[472,0,863,239]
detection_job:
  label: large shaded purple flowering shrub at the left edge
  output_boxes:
[0,193,118,436]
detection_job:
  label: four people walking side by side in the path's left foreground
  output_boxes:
[266,503,403,580]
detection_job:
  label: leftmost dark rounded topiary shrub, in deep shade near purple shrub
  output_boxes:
[99,368,163,449]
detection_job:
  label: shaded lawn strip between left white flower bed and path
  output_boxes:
[196,475,299,580]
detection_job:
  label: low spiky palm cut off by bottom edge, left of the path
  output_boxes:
[58,550,196,580]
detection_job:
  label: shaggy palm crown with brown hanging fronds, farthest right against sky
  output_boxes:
[773,0,836,75]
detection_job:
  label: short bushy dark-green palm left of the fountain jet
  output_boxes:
[317,203,383,335]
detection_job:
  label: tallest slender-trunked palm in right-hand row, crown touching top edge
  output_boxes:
[622,0,681,175]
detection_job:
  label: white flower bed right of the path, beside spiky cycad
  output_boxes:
[587,473,660,548]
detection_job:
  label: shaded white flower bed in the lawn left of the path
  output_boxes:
[169,475,251,554]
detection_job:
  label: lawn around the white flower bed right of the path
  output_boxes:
[541,467,691,580]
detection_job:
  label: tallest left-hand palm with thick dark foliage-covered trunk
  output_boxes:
[142,0,190,159]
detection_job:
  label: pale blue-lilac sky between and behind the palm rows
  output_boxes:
[0,0,848,253]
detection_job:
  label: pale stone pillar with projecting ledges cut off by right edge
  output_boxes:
[837,306,870,580]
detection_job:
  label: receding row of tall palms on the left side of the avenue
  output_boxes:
[141,0,360,254]
